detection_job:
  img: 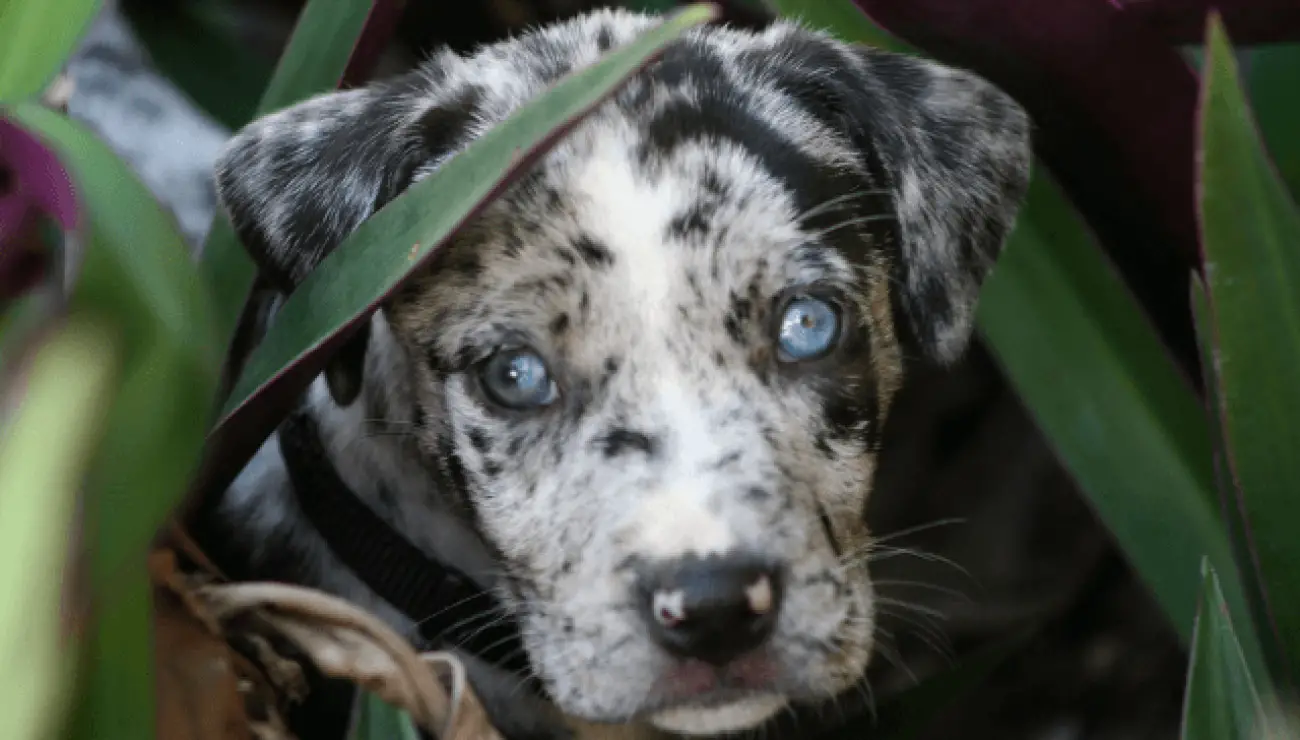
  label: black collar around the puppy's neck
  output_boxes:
[280,411,530,675]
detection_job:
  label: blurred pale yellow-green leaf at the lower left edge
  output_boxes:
[0,316,120,740]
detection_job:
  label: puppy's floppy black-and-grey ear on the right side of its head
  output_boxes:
[779,31,1032,363]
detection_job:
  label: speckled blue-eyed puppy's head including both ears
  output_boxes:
[218,12,1028,733]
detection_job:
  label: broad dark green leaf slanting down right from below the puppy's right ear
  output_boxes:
[978,169,1260,671]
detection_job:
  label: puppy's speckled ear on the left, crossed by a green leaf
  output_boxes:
[216,52,480,406]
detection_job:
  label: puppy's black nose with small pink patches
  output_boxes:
[640,555,781,665]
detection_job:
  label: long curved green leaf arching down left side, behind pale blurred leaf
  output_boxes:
[3,104,218,740]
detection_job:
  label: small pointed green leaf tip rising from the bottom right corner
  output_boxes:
[1182,563,1281,740]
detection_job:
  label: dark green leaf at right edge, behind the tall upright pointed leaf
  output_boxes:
[1242,44,1300,198]
